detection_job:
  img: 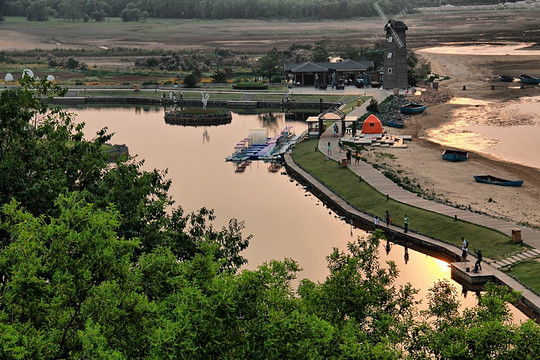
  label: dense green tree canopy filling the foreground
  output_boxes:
[0,77,540,359]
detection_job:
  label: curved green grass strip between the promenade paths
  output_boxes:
[293,140,523,259]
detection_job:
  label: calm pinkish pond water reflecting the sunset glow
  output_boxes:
[74,108,523,317]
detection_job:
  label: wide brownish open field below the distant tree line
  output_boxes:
[0,9,540,55]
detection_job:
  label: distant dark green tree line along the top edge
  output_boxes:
[0,0,512,21]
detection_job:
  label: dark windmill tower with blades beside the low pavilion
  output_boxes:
[374,3,409,89]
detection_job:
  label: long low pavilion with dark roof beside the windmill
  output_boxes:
[283,60,374,85]
